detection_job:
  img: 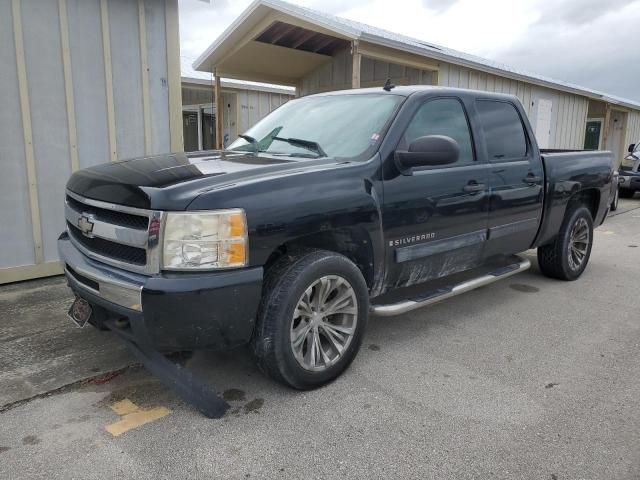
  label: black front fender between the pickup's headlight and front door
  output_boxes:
[189,155,384,281]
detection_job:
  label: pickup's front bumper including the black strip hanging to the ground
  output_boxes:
[58,233,262,418]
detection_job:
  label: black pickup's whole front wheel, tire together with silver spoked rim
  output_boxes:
[251,250,369,390]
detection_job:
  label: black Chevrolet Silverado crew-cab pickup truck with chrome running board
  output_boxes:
[59,86,613,416]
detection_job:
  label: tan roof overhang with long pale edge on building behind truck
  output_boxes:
[193,0,640,110]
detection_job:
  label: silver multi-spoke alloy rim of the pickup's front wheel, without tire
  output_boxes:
[290,275,358,372]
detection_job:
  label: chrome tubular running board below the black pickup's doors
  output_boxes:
[370,257,531,317]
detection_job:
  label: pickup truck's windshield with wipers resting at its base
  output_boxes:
[229,93,403,158]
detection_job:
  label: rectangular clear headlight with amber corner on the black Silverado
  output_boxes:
[162,209,248,270]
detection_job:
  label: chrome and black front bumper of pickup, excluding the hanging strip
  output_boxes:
[58,234,262,350]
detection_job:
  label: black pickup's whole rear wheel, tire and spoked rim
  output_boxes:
[538,205,593,281]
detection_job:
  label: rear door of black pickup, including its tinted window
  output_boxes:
[475,99,544,257]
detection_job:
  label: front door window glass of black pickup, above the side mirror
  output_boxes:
[401,98,474,165]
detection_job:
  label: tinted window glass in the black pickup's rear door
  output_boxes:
[476,100,527,162]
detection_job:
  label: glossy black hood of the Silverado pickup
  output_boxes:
[67,151,335,210]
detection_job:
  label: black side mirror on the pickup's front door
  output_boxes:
[395,135,460,175]
